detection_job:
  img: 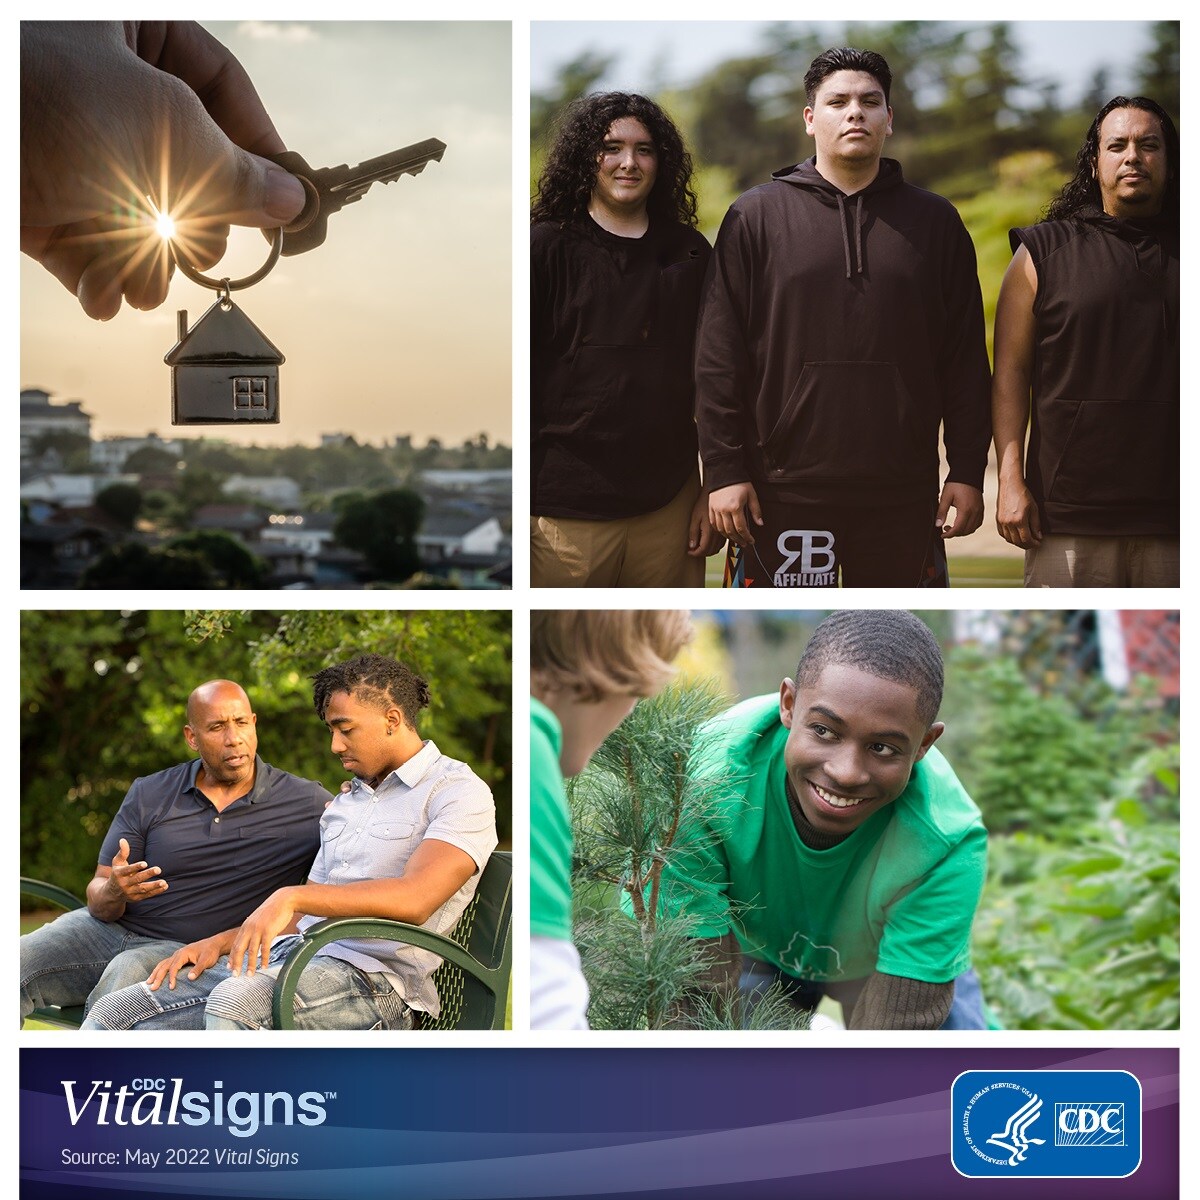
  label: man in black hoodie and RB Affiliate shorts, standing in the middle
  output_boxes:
[696,48,990,587]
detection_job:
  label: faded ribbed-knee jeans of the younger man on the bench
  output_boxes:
[83,934,413,1030]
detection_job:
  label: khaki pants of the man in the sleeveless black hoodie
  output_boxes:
[1025,533,1180,588]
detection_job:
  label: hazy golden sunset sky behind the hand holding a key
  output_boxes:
[20,22,512,445]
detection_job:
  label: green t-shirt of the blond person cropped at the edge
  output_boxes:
[529,696,571,941]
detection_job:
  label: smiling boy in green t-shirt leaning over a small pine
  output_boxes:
[662,610,988,1030]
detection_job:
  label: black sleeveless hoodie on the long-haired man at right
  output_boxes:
[1009,210,1180,536]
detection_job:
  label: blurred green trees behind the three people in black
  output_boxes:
[529,20,1180,357]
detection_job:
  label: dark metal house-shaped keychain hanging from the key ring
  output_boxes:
[163,296,283,425]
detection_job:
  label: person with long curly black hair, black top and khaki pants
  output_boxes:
[529,91,710,588]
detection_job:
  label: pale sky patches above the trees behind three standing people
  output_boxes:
[529,20,1150,101]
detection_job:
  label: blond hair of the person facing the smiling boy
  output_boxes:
[529,610,692,702]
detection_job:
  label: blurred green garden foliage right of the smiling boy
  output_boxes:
[941,643,1180,1030]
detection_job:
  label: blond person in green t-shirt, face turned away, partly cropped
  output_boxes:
[529,611,691,1030]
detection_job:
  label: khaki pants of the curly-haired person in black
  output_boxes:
[529,476,704,588]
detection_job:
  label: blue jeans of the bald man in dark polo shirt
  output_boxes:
[20,908,184,1021]
